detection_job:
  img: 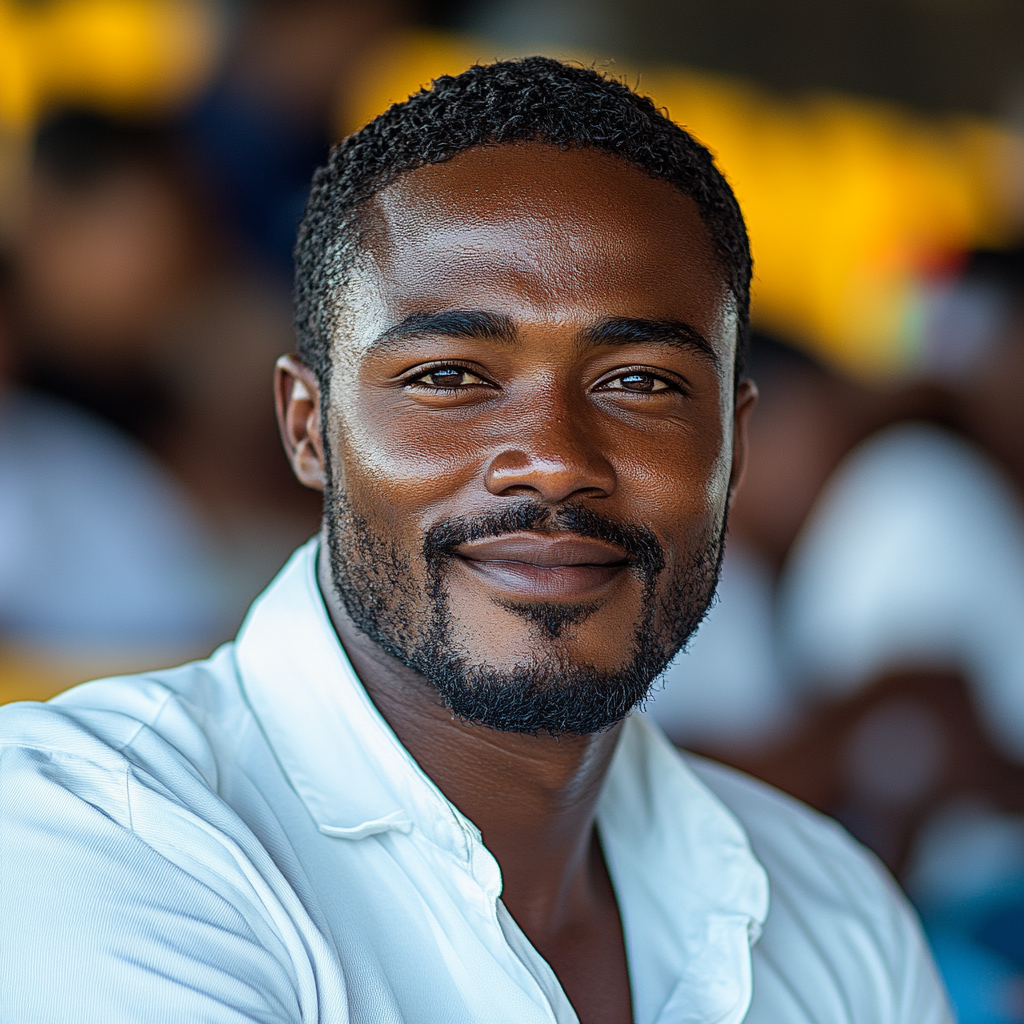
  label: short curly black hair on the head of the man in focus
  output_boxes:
[295,56,751,385]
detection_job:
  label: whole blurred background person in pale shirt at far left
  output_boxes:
[4,110,316,685]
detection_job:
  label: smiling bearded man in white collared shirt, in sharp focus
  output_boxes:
[0,57,948,1024]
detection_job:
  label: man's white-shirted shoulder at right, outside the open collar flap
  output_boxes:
[684,755,951,1024]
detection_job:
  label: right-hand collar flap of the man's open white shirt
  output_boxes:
[597,715,768,1024]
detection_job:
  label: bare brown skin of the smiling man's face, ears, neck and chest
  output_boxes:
[276,143,756,1024]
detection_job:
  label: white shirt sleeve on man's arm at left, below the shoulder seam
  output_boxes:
[0,744,308,1024]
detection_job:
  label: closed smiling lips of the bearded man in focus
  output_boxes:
[457,534,629,601]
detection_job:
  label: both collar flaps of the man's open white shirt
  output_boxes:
[236,540,768,1024]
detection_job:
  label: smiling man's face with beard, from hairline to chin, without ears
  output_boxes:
[315,144,750,732]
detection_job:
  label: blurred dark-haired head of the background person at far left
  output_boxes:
[15,111,193,437]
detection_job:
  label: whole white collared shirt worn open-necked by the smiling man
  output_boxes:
[0,543,949,1024]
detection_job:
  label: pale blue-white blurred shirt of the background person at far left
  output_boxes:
[0,244,229,700]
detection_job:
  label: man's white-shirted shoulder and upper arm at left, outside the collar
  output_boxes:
[0,650,327,1024]
